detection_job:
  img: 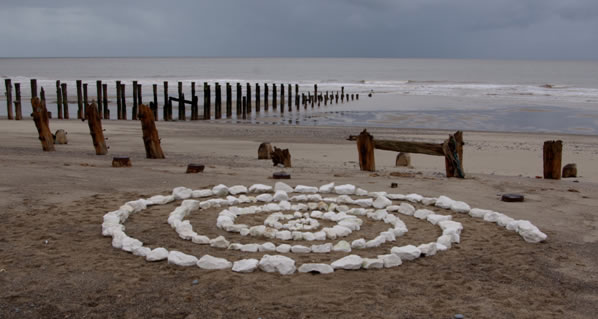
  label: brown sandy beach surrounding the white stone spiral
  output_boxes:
[0,120,598,318]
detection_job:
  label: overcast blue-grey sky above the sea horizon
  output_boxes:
[0,0,598,60]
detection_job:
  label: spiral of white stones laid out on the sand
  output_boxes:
[102,182,547,275]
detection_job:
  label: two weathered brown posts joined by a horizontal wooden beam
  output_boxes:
[348,130,466,178]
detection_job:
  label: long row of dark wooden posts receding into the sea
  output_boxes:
[5,79,359,121]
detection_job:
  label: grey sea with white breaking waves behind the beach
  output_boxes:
[0,58,598,135]
